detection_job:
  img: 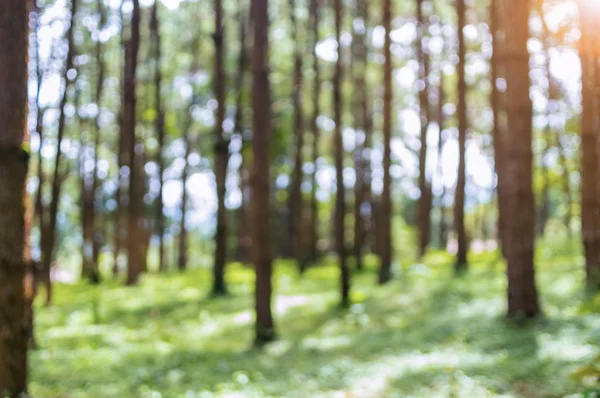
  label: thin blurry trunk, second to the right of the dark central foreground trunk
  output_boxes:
[309,0,321,263]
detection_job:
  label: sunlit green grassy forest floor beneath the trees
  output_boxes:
[31,238,600,398]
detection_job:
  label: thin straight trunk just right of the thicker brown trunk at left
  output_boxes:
[150,0,166,272]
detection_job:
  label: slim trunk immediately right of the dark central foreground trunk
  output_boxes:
[288,0,306,272]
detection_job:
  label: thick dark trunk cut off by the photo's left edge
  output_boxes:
[0,0,29,392]
